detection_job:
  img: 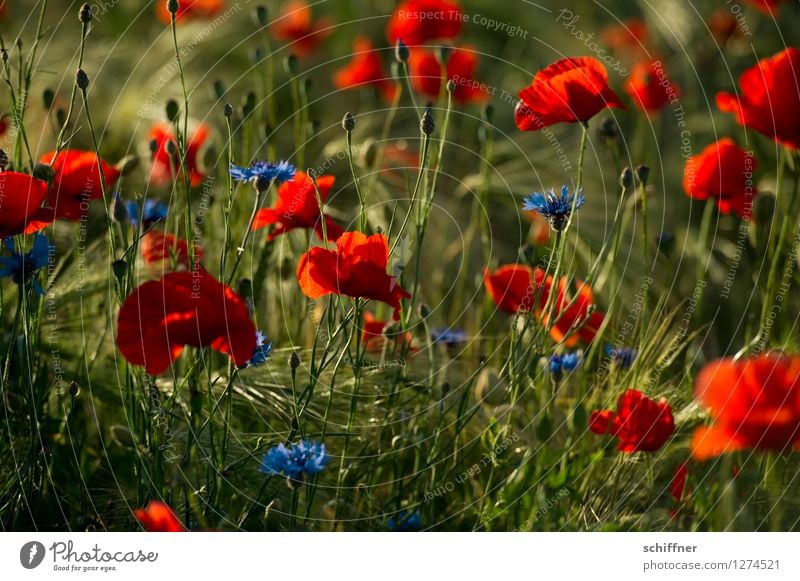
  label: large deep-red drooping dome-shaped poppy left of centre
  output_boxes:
[117,269,256,375]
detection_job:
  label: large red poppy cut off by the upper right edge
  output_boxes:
[717,48,800,149]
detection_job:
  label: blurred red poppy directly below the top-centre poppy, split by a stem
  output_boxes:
[408,47,489,103]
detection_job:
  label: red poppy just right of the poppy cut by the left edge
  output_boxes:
[39,149,119,221]
